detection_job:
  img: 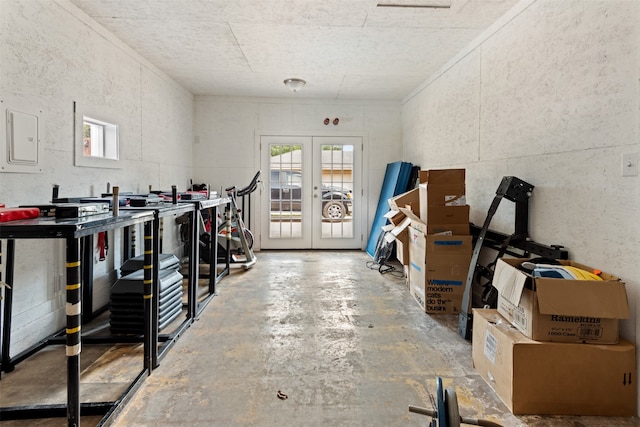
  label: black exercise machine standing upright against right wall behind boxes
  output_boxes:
[458,176,569,340]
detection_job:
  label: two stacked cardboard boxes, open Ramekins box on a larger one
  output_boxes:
[472,259,637,416]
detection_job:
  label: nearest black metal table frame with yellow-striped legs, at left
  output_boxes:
[0,210,155,426]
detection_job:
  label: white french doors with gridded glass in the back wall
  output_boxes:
[260,135,362,249]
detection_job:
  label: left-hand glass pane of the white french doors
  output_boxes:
[269,144,303,239]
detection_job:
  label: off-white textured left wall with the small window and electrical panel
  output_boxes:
[0,0,193,354]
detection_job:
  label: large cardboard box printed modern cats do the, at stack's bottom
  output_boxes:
[408,224,472,314]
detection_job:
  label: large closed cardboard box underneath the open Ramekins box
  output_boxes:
[472,309,637,417]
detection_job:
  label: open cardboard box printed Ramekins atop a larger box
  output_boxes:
[492,258,629,344]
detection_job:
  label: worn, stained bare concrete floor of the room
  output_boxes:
[0,251,640,427]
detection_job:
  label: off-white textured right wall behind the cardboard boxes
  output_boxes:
[403,0,640,402]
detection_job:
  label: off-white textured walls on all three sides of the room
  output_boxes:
[5,0,640,408]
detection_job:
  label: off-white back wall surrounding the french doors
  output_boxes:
[193,95,402,245]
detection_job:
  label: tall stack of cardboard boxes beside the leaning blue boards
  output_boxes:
[399,169,473,314]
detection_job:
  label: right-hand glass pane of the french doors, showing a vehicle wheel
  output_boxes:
[320,144,354,239]
